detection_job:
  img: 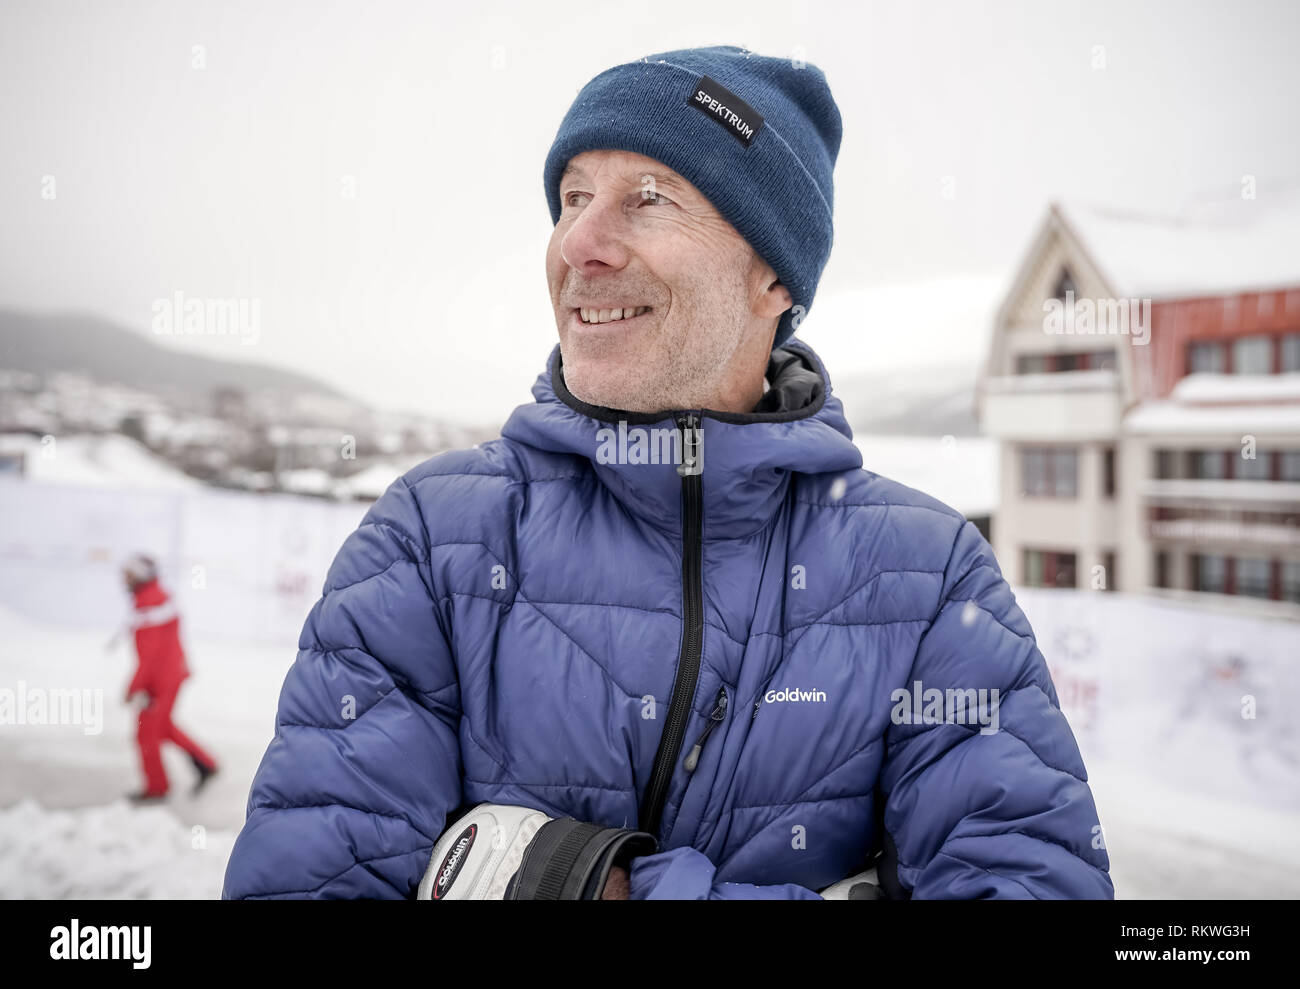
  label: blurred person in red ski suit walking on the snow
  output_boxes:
[122,555,217,802]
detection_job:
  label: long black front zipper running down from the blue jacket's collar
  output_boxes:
[641,412,705,838]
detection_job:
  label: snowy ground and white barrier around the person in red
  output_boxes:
[0,608,287,898]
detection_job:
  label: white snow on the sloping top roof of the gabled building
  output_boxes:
[1056,187,1300,299]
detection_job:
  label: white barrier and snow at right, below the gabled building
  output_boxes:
[1015,587,1300,899]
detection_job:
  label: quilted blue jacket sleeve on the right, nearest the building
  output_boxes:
[880,522,1114,899]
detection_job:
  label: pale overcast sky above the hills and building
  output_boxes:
[0,0,1300,421]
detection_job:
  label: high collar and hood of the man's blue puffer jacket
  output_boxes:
[502,339,862,539]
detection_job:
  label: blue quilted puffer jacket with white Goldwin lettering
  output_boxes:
[224,340,1113,899]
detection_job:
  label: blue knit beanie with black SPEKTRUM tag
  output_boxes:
[543,45,841,347]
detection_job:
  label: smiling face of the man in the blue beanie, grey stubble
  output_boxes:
[546,151,789,412]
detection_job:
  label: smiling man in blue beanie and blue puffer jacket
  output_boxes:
[224,48,1113,899]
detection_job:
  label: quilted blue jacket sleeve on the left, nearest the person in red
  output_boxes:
[222,480,462,899]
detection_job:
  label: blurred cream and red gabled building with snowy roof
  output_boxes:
[976,195,1300,617]
